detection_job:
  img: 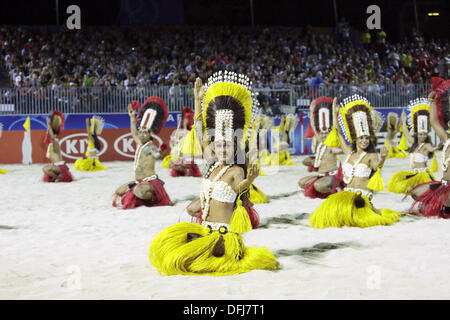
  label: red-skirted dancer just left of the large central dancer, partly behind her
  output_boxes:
[167,107,202,177]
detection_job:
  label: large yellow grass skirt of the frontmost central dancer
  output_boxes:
[149,222,279,276]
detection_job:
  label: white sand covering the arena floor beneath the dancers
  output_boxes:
[0,155,450,299]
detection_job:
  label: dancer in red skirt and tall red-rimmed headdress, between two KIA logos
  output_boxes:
[113,97,172,209]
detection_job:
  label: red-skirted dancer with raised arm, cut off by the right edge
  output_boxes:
[409,77,450,219]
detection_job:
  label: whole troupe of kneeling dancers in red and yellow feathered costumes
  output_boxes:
[2,72,450,276]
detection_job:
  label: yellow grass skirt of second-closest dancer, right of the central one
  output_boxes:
[309,190,401,229]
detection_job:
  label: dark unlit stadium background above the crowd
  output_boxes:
[0,0,450,41]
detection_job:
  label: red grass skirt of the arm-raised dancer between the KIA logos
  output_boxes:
[113,178,172,209]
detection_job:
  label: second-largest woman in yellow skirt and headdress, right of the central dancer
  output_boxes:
[310,95,399,228]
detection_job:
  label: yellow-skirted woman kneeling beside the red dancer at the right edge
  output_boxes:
[388,98,440,194]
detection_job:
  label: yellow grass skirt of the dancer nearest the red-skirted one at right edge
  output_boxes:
[387,169,435,194]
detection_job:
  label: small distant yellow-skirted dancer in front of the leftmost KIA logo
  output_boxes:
[74,116,106,171]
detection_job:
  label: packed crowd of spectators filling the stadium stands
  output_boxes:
[0,25,450,90]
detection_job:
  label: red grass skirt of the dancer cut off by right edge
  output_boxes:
[409,181,450,219]
